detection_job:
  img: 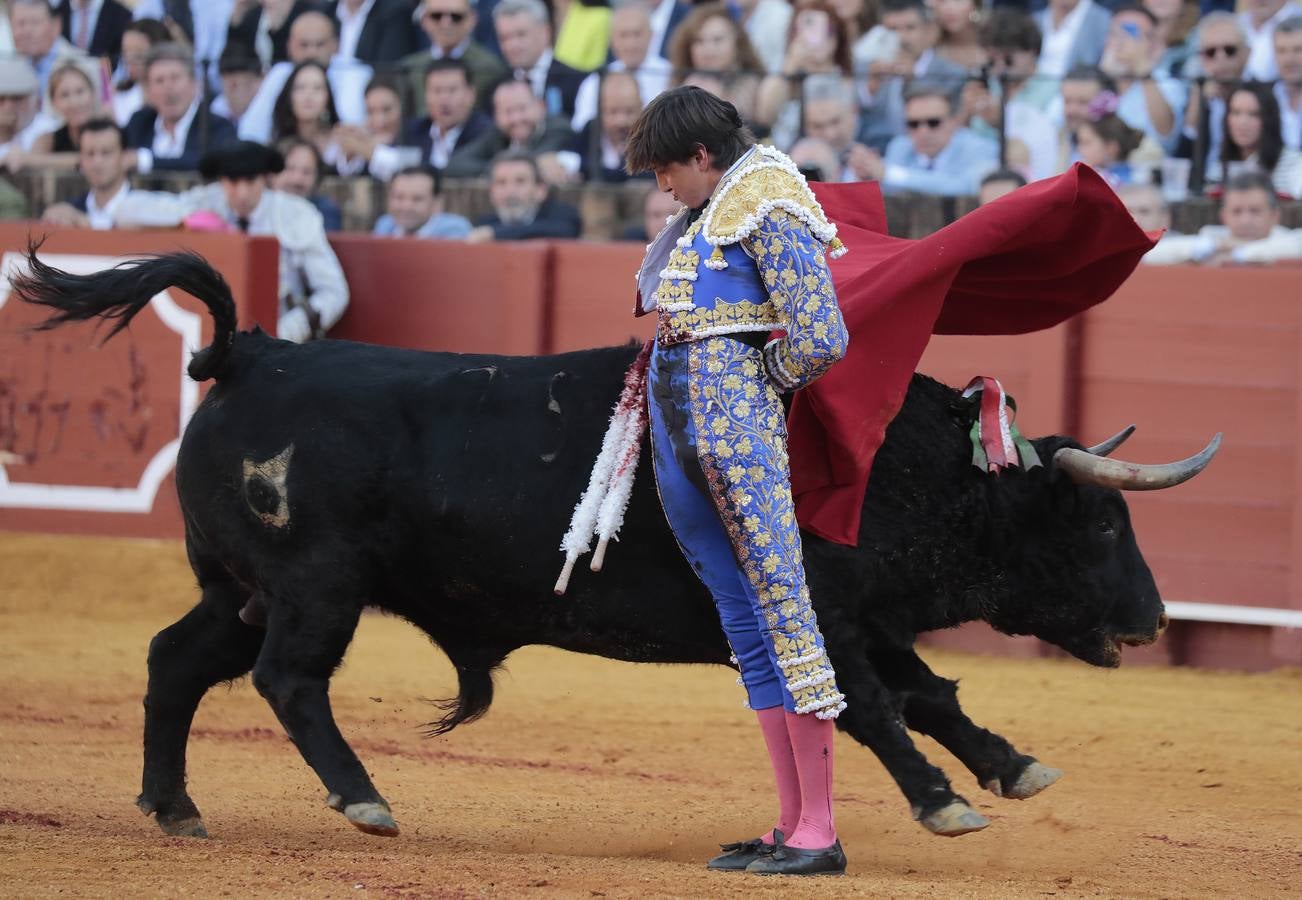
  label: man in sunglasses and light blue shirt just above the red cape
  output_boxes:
[861,82,999,197]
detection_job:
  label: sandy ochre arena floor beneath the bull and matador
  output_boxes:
[0,533,1302,897]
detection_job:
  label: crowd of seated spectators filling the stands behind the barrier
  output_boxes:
[0,0,1302,267]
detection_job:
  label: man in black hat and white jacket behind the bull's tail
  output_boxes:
[116,141,349,343]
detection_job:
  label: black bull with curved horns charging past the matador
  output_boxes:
[14,254,1219,835]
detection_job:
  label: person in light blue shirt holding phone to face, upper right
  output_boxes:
[1099,0,1187,152]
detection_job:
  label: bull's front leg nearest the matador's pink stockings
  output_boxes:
[824,634,990,837]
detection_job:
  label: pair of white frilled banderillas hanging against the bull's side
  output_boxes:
[553,341,654,595]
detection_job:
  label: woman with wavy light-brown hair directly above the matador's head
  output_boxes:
[669,3,764,121]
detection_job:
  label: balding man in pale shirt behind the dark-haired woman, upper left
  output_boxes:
[240,10,372,143]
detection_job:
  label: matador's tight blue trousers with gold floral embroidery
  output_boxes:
[648,337,845,719]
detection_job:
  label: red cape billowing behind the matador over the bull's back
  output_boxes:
[789,164,1154,546]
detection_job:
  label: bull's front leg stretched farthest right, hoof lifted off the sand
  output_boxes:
[868,647,1062,800]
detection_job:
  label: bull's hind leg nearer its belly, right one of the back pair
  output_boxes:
[253,599,398,836]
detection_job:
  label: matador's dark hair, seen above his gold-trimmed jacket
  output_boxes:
[625,86,755,175]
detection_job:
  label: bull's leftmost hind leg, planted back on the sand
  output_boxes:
[137,581,263,837]
